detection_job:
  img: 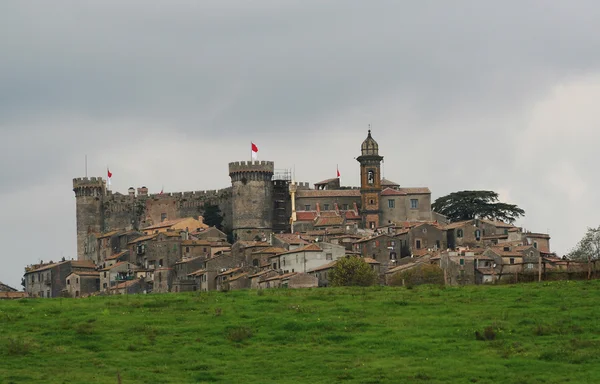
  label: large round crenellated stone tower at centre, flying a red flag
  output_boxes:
[229,161,275,240]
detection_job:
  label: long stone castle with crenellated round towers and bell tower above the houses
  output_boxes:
[73,130,438,259]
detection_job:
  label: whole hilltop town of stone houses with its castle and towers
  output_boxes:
[13,131,578,297]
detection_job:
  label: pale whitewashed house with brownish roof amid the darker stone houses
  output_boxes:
[270,242,346,273]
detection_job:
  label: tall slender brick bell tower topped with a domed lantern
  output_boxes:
[356,129,383,229]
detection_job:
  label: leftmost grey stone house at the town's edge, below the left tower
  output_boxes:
[23,260,96,297]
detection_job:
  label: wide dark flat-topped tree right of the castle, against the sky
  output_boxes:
[431,191,525,223]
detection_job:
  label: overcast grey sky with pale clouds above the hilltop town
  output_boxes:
[0,0,600,288]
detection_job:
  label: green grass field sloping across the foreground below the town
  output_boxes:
[0,281,600,384]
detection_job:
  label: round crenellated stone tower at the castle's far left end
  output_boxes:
[73,177,106,259]
